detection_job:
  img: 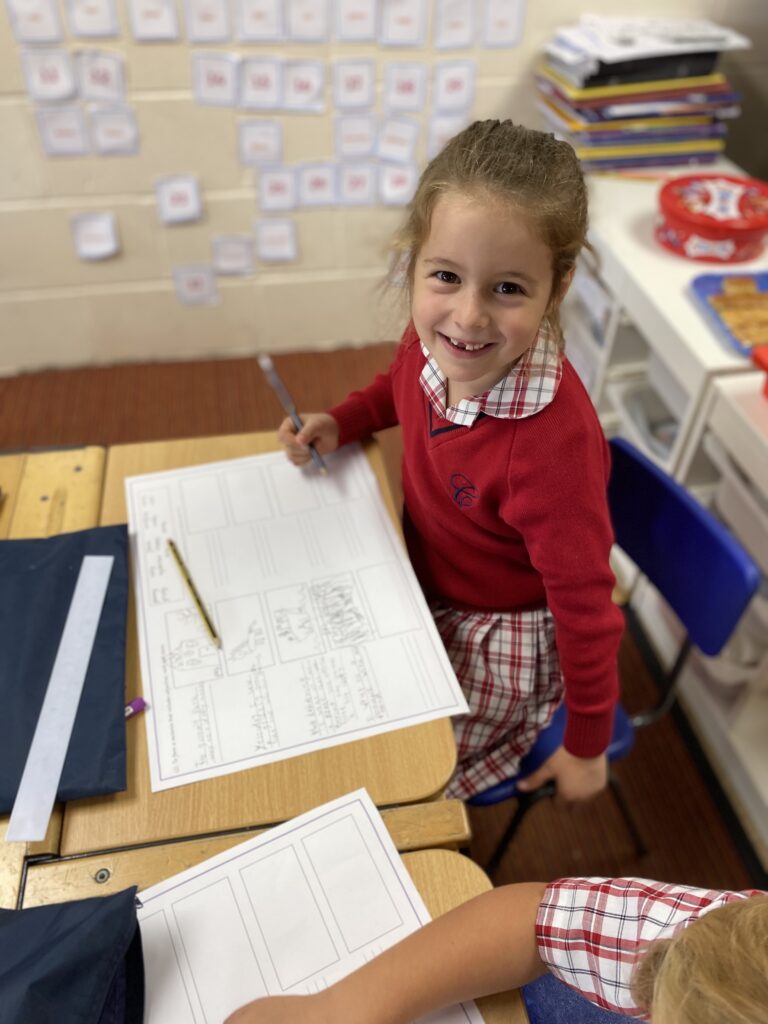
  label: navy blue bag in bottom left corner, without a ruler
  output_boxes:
[0,888,144,1024]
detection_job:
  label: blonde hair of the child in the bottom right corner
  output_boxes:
[632,895,768,1024]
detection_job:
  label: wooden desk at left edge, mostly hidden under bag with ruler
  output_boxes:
[0,447,105,907]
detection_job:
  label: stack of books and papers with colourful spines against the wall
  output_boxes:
[537,14,751,171]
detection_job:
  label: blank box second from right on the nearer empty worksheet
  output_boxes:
[241,847,339,991]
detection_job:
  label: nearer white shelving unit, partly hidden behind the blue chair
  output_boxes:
[636,373,768,867]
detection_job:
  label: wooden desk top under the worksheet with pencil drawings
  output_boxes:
[60,432,456,855]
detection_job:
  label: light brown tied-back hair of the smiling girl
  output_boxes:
[393,121,588,345]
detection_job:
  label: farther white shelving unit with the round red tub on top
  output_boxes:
[563,161,768,474]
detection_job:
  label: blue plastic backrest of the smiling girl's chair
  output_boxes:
[608,437,760,655]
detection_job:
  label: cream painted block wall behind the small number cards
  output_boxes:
[0,0,768,375]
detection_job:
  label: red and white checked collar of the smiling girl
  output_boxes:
[419,325,562,427]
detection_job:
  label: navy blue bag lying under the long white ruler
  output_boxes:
[0,525,128,813]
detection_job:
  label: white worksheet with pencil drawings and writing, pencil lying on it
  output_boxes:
[126,445,467,792]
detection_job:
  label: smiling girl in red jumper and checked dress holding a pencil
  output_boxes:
[279,121,623,800]
